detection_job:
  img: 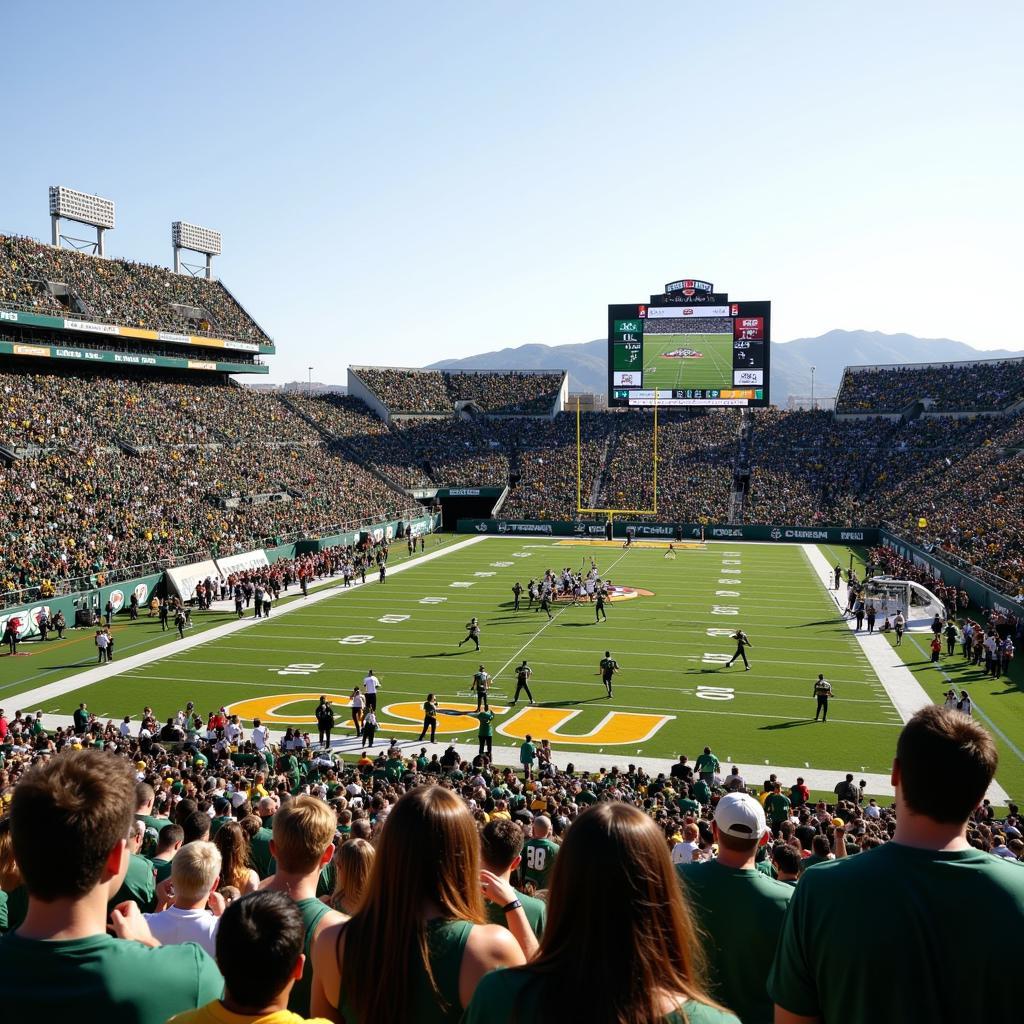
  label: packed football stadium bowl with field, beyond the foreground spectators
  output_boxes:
[0,197,1024,1015]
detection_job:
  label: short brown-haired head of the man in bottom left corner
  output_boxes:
[10,750,135,902]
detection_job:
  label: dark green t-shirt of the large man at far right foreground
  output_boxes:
[768,843,1024,1024]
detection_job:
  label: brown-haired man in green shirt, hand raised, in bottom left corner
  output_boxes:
[0,750,223,1024]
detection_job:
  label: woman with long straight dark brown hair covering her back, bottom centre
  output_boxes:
[466,803,738,1024]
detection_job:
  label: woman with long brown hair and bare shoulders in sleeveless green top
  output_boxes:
[311,785,529,1024]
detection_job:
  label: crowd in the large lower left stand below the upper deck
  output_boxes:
[0,374,408,592]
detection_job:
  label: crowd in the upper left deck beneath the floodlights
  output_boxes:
[0,236,270,343]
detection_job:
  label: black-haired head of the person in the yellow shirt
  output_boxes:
[217,892,305,1011]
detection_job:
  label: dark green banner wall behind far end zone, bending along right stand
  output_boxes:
[456,519,1024,618]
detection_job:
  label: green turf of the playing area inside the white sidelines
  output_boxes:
[8,539,898,771]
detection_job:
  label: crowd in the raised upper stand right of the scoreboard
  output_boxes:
[836,359,1024,413]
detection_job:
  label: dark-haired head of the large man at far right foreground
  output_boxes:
[893,705,998,824]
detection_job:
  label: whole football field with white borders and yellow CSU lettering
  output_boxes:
[6,537,1022,793]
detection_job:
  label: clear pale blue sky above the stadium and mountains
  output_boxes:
[0,0,1024,382]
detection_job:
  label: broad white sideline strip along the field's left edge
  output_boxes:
[4,537,486,714]
